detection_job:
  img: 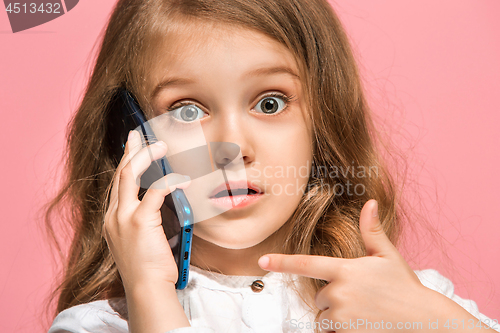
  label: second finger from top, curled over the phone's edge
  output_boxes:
[118,141,167,209]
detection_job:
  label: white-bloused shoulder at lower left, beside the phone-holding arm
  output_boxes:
[48,300,129,333]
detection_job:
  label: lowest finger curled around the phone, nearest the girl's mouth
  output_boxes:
[137,173,191,215]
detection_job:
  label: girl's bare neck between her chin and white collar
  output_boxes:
[191,224,283,276]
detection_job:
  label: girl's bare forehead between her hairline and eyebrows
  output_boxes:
[151,23,299,93]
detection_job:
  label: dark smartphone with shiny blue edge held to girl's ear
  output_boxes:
[107,88,194,289]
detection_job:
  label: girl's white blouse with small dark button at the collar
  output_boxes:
[48,266,500,333]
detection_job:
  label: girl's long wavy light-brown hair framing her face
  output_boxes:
[45,0,422,326]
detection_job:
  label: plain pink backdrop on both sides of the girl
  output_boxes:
[0,0,500,332]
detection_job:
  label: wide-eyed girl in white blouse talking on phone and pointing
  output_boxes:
[47,0,498,333]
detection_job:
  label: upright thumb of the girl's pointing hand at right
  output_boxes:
[359,199,399,257]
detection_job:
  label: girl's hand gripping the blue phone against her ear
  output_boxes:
[103,132,190,291]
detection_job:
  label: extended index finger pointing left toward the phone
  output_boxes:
[258,253,349,282]
